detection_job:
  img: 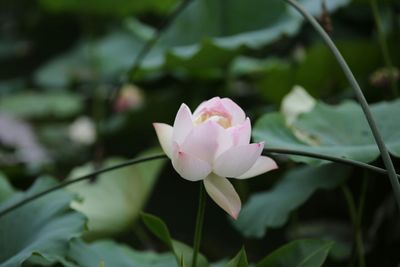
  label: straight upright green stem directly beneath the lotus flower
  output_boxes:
[192,182,206,267]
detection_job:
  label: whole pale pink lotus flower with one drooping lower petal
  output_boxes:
[153,97,277,219]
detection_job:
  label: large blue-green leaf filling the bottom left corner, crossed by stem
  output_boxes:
[0,178,86,267]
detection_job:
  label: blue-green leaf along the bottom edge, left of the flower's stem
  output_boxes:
[64,239,176,267]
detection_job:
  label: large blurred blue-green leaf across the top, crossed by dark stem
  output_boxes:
[36,0,349,86]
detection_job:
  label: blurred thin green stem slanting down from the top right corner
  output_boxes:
[369,0,399,97]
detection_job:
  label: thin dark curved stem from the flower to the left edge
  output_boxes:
[0,154,166,218]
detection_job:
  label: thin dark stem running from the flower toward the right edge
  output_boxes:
[264,148,400,179]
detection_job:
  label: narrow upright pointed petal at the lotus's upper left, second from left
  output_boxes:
[172,104,193,144]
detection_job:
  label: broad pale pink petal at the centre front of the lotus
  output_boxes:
[181,121,224,164]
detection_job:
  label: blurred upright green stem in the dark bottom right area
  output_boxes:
[342,185,365,267]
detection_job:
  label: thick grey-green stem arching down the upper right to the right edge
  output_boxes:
[284,0,400,214]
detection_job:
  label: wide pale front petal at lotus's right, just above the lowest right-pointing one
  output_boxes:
[214,143,264,177]
